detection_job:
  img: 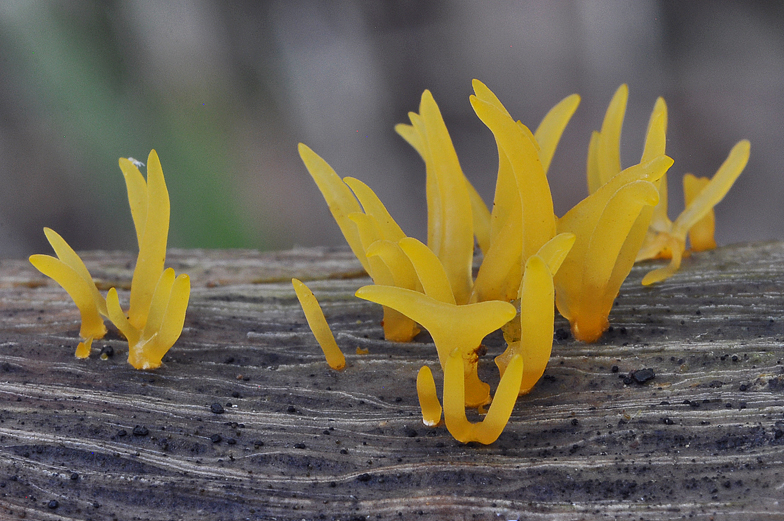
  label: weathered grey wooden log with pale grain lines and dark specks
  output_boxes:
[0,243,784,520]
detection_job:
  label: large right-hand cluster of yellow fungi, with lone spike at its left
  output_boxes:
[293,80,749,444]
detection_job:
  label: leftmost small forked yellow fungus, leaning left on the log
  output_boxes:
[30,228,107,358]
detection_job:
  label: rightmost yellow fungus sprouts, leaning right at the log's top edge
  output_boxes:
[637,139,751,286]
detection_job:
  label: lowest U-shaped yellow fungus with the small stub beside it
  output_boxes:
[417,349,523,445]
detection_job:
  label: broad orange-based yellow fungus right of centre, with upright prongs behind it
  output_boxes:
[554,85,684,342]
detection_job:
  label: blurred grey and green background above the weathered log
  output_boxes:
[0,0,784,257]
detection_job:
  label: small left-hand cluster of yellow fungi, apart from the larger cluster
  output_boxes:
[30,150,191,369]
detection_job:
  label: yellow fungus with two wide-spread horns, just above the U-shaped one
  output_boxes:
[356,286,517,407]
